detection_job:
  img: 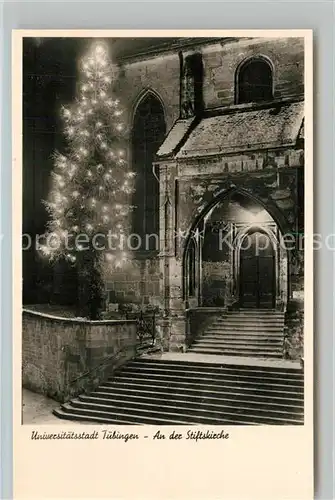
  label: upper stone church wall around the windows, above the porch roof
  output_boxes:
[112,38,304,122]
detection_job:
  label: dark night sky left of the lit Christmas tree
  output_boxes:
[22,38,79,303]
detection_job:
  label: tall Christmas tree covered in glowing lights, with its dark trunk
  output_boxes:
[41,43,134,319]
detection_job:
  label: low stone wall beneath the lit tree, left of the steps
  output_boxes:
[22,309,137,401]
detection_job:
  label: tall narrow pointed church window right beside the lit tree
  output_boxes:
[132,93,166,250]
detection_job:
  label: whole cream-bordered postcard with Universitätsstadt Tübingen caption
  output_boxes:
[12,30,313,500]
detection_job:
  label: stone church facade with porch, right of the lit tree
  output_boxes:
[105,38,304,359]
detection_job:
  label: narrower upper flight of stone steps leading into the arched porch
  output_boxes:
[188,309,284,358]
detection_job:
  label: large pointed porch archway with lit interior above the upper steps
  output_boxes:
[183,190,289,311]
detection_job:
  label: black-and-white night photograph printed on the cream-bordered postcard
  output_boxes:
[21,32,312,426]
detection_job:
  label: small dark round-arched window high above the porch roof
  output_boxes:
[236,58,273,104]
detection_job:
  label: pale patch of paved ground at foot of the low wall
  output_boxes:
[22,389,73,425]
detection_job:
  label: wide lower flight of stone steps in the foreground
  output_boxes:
[54,354,304,425]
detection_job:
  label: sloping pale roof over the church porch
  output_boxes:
[157,101,304,159]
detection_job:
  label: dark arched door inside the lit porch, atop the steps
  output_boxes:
[239,229,276,309]
